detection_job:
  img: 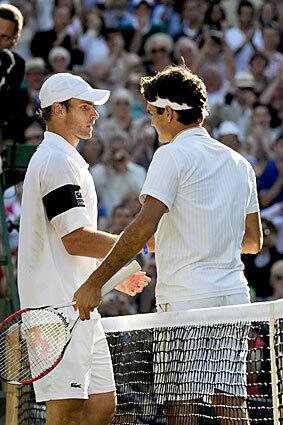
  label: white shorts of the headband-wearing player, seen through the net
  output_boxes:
[153,294,250,402]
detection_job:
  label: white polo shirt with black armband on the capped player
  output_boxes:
[18,131,98,317]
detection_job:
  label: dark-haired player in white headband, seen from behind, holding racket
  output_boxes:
[74,66,262,425]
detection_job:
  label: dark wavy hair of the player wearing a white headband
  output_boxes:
[140,65,207,125]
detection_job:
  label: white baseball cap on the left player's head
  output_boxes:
[39,72,110,108]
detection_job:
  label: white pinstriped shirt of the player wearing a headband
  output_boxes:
[140,128,259,304]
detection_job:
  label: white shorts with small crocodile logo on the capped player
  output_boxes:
[33,319,115,402]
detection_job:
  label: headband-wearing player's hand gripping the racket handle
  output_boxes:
[73,280,101,320]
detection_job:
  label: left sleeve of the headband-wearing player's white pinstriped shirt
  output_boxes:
[140,146,179,210]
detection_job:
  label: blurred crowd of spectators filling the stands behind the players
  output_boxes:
[0,0,283,316]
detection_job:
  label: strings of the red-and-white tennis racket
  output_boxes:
[0,309,68,382]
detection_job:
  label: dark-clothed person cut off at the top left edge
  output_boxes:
[0,4,25,144]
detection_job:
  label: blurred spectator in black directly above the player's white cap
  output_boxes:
[30,6,84,66]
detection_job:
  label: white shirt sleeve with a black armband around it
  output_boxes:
[41,154,92,238]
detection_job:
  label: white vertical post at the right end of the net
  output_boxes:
[269,302,279,425]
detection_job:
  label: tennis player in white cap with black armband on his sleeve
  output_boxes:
[18,73,150,425]
